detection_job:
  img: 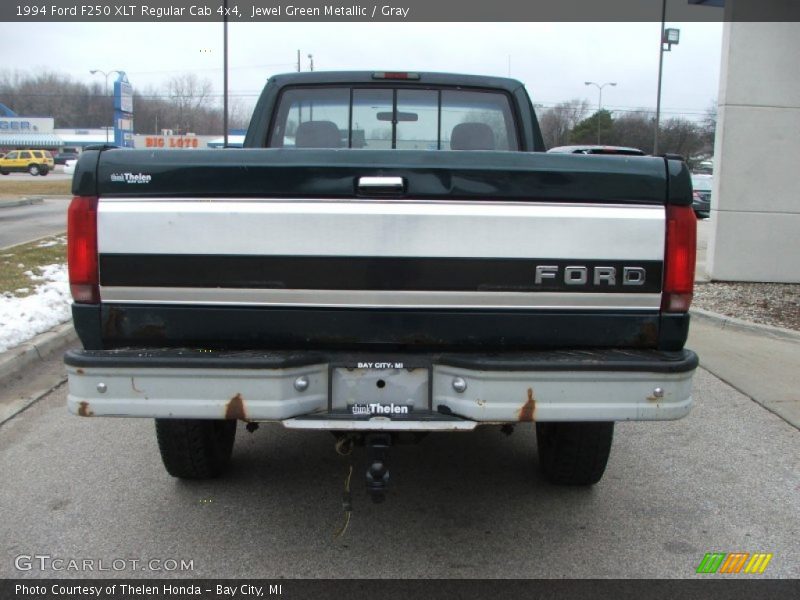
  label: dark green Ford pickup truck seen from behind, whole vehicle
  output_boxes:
[65,72,697,500]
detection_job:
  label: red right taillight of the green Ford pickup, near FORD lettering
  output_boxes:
[661,206,697,312]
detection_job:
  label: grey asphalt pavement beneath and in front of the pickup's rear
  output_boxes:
[0,359,800,578]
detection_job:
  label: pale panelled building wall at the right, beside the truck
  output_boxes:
[706,6,800,283]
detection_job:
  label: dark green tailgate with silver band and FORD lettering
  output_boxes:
[74,150,691,351]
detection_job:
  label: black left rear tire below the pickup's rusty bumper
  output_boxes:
[156,419,237,479]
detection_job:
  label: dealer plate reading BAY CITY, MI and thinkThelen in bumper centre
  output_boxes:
[330,362,430,419]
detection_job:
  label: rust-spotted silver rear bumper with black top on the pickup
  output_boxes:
[65,349,697,431]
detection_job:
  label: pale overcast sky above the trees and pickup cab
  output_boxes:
[0,21,723,119]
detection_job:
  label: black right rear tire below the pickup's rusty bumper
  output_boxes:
[536,421,614,485]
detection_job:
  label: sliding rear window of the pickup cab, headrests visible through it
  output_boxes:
[268,86,519,150]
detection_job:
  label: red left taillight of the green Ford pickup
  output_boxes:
[67,196,100,304]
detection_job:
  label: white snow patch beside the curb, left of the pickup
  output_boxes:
[0,265,72,352]
